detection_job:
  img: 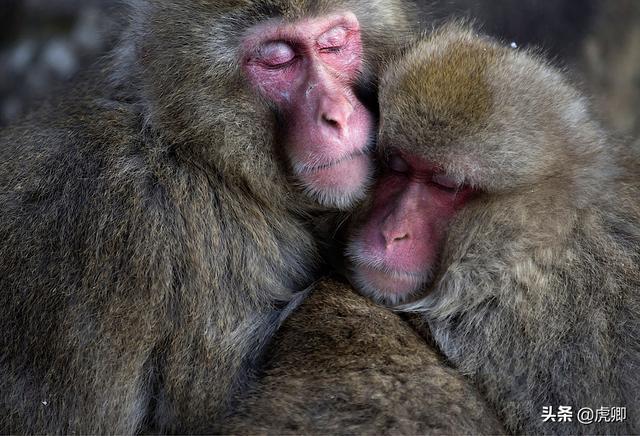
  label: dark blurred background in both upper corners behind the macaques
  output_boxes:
[0,0,640,147]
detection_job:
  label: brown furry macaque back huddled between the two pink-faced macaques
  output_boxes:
[222,279,504,435]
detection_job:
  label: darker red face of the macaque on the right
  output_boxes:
[348,152,474,304]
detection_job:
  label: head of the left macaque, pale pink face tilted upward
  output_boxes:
[127,0,413,208]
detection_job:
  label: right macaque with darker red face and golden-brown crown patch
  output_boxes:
[349,25,640,434]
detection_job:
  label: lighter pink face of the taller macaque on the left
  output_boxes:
[243,13,374,207]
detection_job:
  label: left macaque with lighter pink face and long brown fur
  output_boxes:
[0,0,410,434]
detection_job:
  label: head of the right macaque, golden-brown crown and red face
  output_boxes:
[348,26,598,304]
